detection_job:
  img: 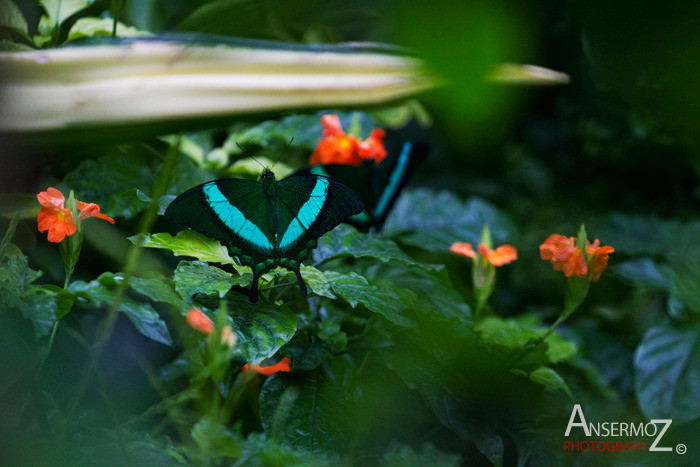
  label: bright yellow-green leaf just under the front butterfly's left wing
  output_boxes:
[129,230,233,264]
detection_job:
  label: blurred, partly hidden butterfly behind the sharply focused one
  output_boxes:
[293,141,428,230]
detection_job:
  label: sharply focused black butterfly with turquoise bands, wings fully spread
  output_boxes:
[165,170,364,302]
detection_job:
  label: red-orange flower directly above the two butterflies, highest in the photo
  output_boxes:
[309,115,386,165]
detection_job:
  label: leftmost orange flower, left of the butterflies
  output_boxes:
[36,187,114,243]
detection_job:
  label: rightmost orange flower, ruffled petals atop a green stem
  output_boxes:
[540,234,615,282]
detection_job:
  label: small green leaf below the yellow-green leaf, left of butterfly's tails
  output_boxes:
[173,261,239,303]
